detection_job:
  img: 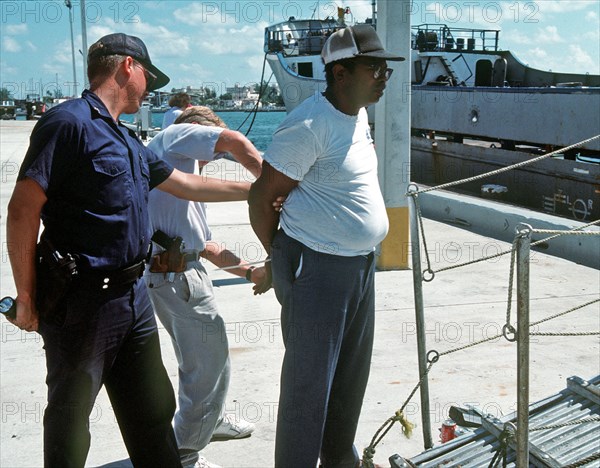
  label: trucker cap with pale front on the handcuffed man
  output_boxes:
[321,24,404,65]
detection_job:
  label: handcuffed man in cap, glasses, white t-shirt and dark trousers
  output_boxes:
[249,25,403,468]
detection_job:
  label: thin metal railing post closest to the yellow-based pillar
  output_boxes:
[408,192,433,449]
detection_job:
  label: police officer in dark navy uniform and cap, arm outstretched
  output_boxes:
[7,33,249,468]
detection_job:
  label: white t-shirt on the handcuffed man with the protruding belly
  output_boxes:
[264,94,388,256]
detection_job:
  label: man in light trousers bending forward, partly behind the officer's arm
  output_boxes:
[144,106,265,468]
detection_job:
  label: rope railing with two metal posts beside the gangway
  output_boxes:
[362,135,600,468]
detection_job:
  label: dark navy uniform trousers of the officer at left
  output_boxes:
[40,280,181,468]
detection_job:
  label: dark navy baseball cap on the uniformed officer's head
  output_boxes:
[88,33,170,91]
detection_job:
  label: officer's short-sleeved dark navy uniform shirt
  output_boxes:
[19,90,173,271]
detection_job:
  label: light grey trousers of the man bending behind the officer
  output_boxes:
[144,262,230,466]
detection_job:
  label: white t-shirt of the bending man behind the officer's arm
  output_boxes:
[148,124,224,252]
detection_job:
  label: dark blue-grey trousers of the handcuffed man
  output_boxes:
[271,230,375,468]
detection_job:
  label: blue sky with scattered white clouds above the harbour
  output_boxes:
[0,0,600,98]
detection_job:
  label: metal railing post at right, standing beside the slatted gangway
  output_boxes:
[516,225,531,467]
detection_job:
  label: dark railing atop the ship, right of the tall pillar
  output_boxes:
[412,23,500,52]
